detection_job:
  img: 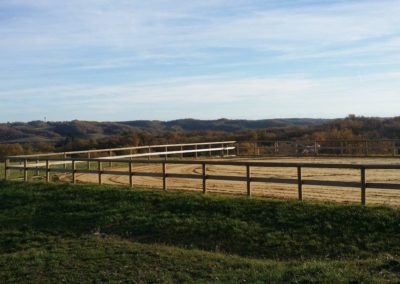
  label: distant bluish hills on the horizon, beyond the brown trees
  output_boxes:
[0,118,328,143]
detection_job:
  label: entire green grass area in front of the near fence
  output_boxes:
[0,182,400,283]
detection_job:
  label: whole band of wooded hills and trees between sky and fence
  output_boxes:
[0,115,400,157]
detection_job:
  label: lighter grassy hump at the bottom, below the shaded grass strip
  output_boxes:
[0,236,400,283]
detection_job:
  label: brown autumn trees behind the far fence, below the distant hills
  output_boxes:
[0,115,400,158]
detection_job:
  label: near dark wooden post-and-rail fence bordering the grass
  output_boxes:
[5,157,400,205]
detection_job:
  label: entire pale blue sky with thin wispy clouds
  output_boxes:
[0,0,400,121]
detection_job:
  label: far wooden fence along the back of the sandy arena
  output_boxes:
[8,139,400,162]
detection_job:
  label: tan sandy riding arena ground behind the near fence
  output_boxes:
[65,158,400,207]
